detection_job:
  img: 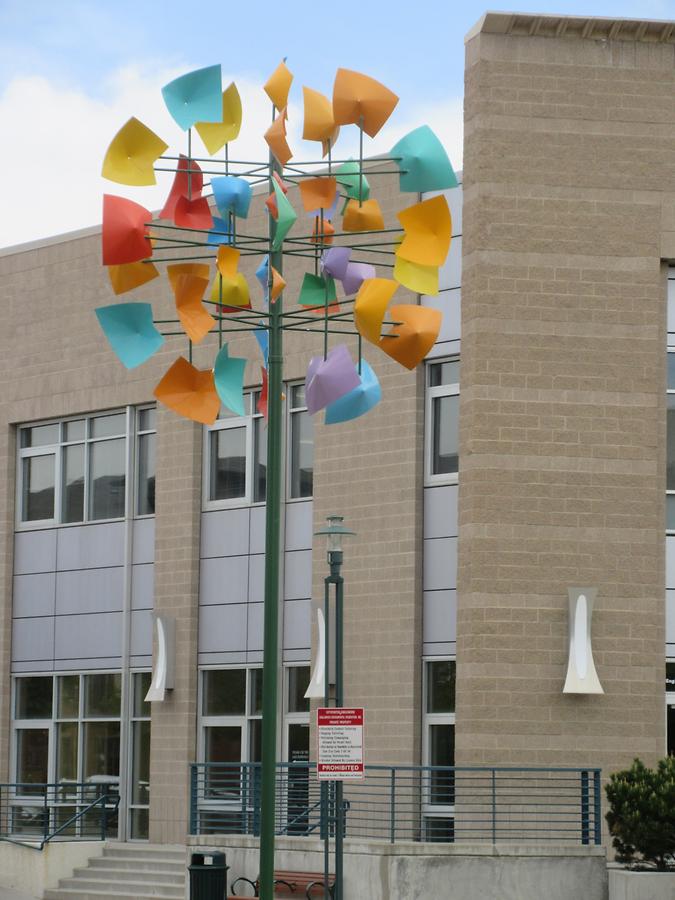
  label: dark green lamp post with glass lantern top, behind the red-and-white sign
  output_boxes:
[314,515,356,900]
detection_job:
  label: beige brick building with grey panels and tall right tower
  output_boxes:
[0,13,675,856]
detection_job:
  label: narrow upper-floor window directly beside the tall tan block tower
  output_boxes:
[426,359,459,482]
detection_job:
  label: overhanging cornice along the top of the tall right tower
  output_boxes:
[464,12,675,44]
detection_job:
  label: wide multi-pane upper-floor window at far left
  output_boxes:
[17,407,155,527]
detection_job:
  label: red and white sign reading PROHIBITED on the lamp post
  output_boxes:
[316,707,365,781]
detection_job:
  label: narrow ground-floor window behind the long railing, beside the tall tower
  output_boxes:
[423,659,455,841]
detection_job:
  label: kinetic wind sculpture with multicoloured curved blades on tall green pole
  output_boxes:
[96,62,457,897]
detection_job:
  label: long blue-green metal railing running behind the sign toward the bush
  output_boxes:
[190,763,602,844]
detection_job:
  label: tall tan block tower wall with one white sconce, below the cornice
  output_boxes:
[457,24,675,773]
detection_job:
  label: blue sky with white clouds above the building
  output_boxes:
[0,0,675,247]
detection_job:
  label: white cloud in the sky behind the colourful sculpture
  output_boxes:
[0,66,462,247]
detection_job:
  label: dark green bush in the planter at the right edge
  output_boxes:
[605,756,675,870]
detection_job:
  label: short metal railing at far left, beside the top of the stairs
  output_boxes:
[0,782,120,850]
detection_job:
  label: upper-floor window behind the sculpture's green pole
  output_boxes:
[204,384,314,509]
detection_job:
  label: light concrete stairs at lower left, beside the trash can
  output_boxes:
[44,843,186,900]
